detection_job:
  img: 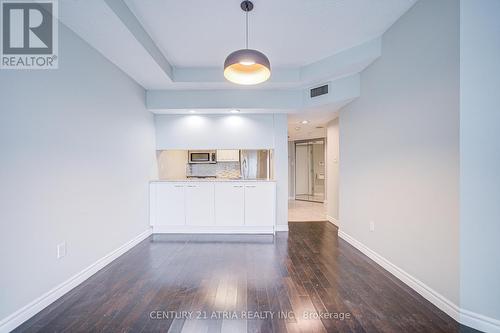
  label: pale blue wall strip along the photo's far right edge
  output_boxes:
[460,0,500,322]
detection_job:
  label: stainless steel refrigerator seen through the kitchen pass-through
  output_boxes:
[240,149,271,179]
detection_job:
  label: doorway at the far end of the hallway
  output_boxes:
[295,138,325,203]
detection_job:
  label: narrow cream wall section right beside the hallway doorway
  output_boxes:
[326,118,339,219]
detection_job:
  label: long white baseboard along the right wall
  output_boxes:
[338,230,500,333]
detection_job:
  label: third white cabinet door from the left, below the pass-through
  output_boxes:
[215,182,245,226]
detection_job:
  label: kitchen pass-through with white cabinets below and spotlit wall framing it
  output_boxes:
[149,114,288,234]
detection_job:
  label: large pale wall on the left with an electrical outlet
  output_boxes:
[0,26,155,320]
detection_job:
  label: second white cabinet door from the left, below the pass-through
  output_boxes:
[186,182,215,226]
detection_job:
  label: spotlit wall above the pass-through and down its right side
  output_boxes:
[155,114,288,226]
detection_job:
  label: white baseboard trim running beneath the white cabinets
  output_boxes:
[153,225,274,234]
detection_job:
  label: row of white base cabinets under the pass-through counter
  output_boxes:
[150,180,276,233]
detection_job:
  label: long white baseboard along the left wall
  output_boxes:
[0,228,151,333]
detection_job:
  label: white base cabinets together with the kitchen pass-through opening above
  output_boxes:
[150,149,276,233]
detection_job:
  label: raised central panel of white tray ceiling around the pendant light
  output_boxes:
[126,0,416,67]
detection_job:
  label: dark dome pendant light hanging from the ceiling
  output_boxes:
[224,1,271,85]
